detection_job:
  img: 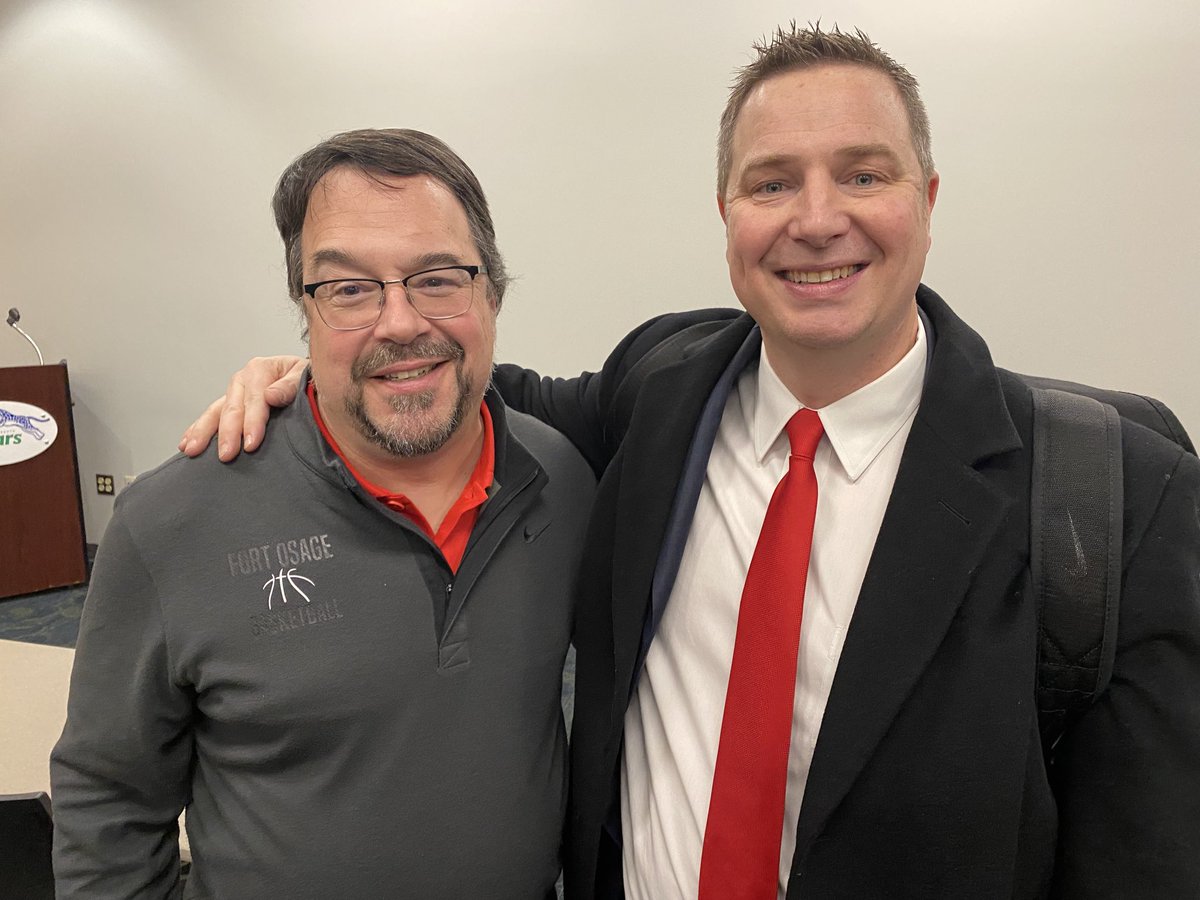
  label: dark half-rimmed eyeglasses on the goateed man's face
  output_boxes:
[304,265,487,331]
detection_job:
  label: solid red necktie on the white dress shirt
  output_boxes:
[700,409,823,900]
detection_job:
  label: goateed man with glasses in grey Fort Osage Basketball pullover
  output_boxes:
[52,131,594,900]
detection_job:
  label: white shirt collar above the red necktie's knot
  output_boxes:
[738,317,926,481]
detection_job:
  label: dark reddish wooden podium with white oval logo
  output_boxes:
[0,364,88,598]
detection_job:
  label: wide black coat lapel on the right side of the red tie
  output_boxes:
[793,287,1020,865]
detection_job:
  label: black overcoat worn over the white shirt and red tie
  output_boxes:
[497,287,1200,900]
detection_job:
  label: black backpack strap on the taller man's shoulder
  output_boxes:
[1030,388,1124,755]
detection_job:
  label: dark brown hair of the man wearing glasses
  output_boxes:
[271,128,509,306]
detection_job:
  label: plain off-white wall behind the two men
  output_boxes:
[0,0,1200,541]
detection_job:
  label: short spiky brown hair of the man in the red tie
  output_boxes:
[716,22,934,197]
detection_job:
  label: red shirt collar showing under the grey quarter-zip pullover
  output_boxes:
[308,382,496,572]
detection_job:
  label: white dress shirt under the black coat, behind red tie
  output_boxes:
[620,323,926,900]
